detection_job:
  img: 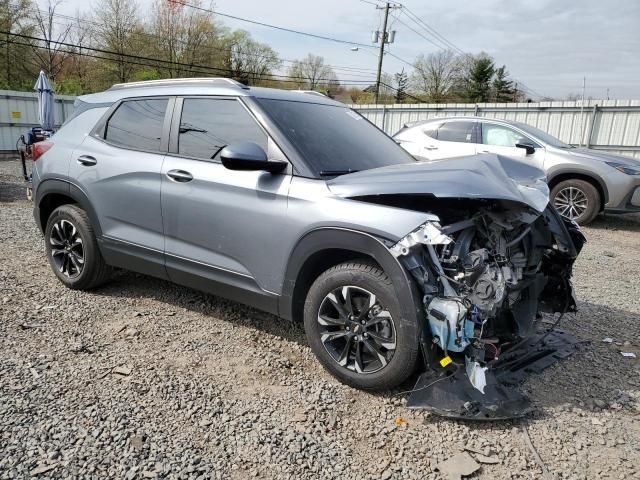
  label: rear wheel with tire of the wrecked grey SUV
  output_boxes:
[44,205,111,290]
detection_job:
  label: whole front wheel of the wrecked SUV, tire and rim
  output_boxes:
[304,261,419,390]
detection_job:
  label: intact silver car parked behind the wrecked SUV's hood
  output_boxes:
[394,117,640,224]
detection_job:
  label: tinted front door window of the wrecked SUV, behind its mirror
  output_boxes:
[178,98,267,160]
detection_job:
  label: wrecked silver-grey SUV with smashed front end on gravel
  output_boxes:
[33,79,582,402]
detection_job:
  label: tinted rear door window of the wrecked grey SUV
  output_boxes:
[104,98,168,152]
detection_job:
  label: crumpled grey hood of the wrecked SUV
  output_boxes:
[327,153,549,212]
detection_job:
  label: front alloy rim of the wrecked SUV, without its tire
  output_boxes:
[318,286,396,374]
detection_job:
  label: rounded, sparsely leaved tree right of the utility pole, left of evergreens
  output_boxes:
[411,50,460,103]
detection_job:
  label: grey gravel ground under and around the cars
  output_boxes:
[0,161,640,479]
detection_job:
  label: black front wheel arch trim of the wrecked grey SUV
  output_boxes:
[278,227,422,333]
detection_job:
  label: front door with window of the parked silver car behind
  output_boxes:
[478,122,545,169]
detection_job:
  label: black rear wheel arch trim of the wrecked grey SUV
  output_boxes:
[34,179,102,237]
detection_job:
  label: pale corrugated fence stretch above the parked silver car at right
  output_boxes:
[352,100,640,158]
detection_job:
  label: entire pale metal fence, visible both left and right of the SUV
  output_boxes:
[0,90,640,158]
